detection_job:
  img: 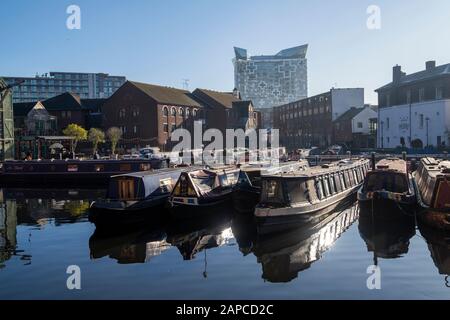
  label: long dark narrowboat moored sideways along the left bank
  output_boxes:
[0,159,167,187]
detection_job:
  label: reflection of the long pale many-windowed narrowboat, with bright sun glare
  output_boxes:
[253,204,358,282]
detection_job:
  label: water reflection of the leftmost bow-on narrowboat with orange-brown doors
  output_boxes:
[89,229,170,264]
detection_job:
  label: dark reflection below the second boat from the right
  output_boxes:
[358,208,416,264]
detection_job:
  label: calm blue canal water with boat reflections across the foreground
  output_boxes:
[0,189,450,299]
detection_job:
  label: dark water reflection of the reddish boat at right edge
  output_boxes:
[419,222,450,287]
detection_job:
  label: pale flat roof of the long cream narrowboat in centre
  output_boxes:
[264,158,369,178]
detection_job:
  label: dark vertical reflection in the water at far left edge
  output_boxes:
[0,195,17,268]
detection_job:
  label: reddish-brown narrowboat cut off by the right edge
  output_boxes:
[414,158,450,230]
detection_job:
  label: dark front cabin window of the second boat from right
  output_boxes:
[365,172,408,193]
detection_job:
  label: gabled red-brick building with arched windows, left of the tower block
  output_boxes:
[102,81,202,150]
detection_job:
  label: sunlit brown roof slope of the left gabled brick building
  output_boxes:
[127,81,201,107]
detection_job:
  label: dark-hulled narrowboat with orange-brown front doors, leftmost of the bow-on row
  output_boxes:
[89,168,188,226]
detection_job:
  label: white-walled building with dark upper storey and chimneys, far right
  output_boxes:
[376,61,450,148]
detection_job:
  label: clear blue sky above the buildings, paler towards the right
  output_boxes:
[0,0,450,103]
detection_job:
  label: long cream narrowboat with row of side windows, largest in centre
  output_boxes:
[255,159,369,229]
